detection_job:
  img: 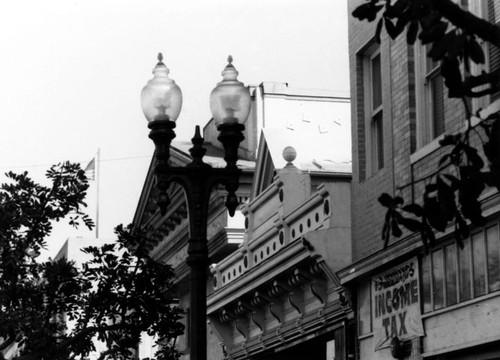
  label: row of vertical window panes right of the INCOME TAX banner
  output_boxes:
[422,223,500,312]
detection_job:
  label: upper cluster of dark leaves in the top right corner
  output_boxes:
[352,0,500,98]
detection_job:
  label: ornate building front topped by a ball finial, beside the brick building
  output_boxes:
[208,129,354,360]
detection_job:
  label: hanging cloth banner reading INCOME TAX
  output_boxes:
[372,258,424,350]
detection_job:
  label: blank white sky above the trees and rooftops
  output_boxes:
[0,0,349,256]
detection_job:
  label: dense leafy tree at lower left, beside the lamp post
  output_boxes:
[0,163,183,360]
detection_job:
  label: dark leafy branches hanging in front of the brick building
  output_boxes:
[353,0,500,248]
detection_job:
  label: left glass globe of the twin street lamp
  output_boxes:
[141,53,182,122]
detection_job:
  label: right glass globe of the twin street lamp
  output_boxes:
[210,55,250,126]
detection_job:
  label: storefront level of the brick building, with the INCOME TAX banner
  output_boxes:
[339,218,500,360]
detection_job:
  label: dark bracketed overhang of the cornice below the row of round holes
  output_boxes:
[209,253,352,359]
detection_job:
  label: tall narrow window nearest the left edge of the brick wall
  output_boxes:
[363,44,384,174]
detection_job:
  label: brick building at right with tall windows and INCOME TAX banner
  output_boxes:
[338,0,500,360]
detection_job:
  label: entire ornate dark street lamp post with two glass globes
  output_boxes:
[141,53,250,360]
